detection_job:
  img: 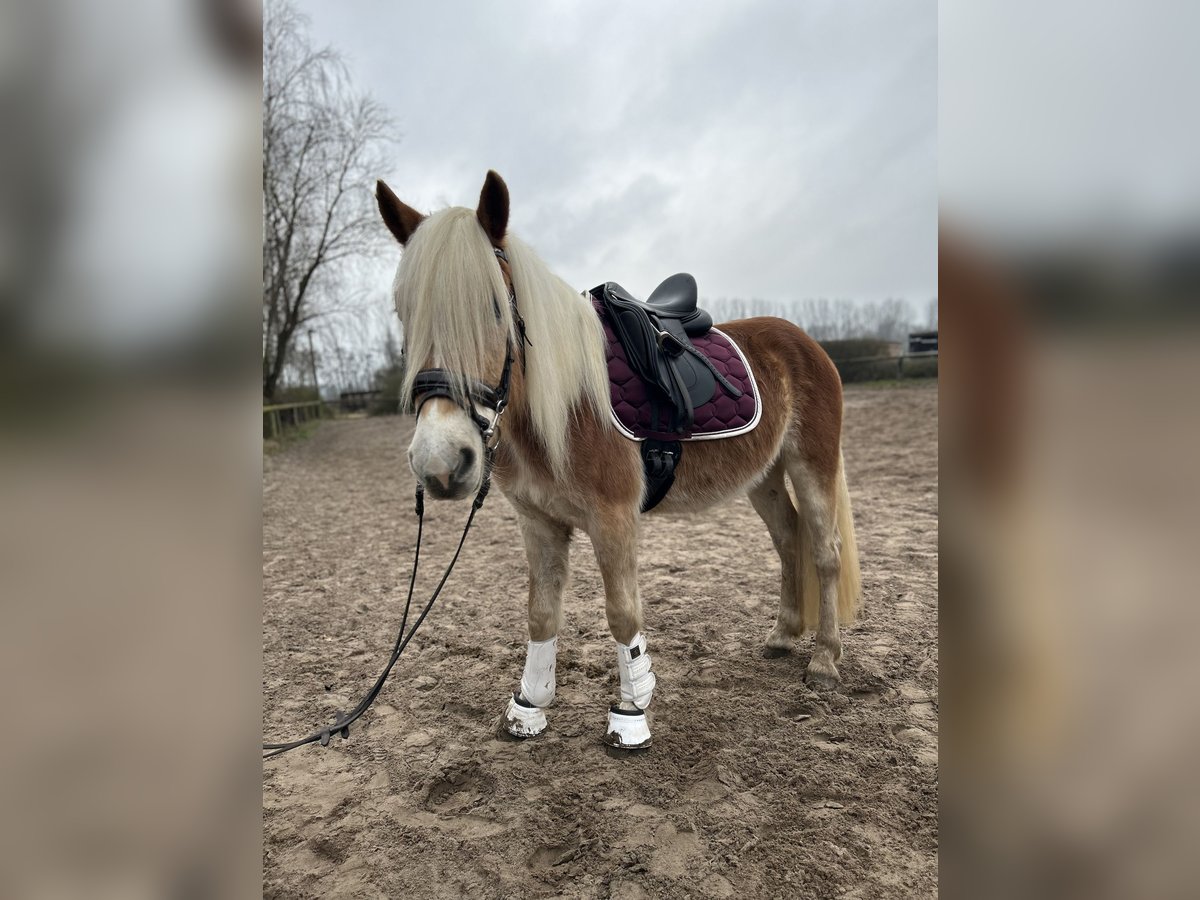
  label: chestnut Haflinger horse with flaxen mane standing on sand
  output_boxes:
[377,172,860,749]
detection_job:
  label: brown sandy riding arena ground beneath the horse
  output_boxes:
[263,383,937,898]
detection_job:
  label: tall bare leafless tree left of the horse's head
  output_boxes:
[263,0,391,397]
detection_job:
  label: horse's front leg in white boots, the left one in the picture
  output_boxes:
[504,512,571,738]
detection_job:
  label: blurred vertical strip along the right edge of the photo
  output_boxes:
[938,2,1200,898]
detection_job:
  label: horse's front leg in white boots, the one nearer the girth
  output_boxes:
[589,510,655,750]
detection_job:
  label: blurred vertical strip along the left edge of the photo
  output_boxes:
[0,0,262,898]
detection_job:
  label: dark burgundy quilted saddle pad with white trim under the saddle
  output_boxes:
[588,295,762,440]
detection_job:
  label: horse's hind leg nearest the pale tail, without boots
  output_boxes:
[788,463,841,689]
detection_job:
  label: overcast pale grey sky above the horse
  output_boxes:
[292,0,937,310]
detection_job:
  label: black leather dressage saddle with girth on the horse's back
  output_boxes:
[592,272,742,511]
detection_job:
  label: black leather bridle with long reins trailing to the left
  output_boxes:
[263,247,533,760]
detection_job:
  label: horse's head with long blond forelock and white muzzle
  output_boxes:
[376,172,516,500]
